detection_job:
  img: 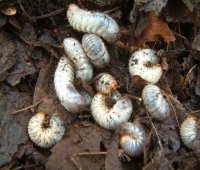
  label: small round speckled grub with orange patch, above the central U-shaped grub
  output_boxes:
[95,73,118,94]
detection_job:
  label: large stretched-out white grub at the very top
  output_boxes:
[67,4,119,43]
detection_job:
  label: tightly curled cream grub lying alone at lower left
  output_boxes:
[28,112,65,148]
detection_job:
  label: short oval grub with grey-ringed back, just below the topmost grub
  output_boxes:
[82,34,110,68]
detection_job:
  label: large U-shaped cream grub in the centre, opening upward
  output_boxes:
[91,93,133,129]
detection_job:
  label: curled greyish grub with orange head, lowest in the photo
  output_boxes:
[118,122,146,156]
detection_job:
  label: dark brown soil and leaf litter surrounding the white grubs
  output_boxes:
[0,0,200,170]
